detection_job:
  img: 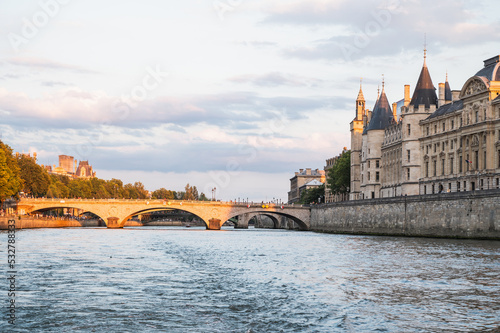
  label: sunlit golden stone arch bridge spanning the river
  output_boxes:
[17,198,311,230]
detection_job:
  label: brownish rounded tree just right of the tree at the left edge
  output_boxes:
[17,154,50,197]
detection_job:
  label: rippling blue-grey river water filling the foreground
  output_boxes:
[0,227,500,333]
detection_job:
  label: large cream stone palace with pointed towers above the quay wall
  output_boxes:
[350,53,500,200]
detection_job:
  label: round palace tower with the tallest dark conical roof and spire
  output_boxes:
[401,48,438,195]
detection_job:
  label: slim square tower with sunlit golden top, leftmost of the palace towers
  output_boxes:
[349,83,366,200]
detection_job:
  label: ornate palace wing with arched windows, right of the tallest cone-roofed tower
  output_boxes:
[419,55,500,194]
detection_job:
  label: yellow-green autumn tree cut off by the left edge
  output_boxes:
[0,141,22,202]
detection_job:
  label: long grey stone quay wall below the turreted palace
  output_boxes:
[310,190,500,240]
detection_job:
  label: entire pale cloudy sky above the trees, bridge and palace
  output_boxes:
[0,0,500,201]
